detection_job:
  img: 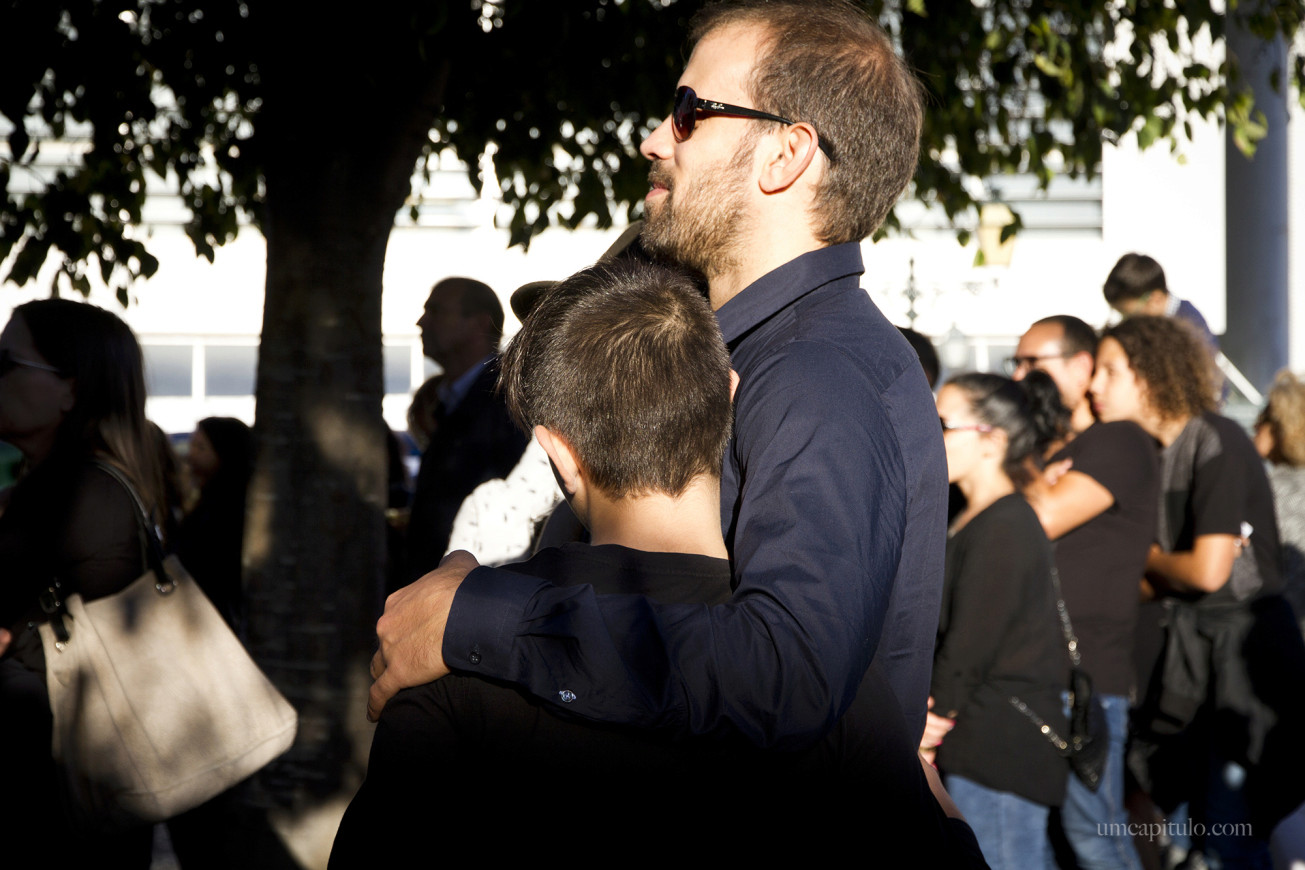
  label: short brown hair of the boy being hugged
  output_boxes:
[499,260,733,498]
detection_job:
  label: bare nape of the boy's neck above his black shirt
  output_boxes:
[586,475,729,558]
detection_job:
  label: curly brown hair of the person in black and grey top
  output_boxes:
[1101,316,1219,421]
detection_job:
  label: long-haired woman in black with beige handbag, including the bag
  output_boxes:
[0,299,295,867]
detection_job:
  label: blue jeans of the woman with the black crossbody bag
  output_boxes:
[946,776,1051,870]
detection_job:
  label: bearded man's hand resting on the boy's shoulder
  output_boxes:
[367,550,480,721]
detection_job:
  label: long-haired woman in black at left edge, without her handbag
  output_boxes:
[0,299,163,866]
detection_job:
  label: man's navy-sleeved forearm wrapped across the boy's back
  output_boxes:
[445,560,869,747]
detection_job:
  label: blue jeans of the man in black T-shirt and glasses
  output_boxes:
[1048,695,1142,870]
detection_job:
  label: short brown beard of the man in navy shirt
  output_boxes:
[639,147,753,278]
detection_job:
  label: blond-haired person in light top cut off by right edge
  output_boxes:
[1255,372,1305,631]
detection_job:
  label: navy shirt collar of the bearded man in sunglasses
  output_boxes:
[716,241,865,346]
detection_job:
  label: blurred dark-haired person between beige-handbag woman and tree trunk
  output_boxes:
[176,417,254,635]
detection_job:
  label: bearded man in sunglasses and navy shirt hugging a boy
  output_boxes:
[368,0,946,747]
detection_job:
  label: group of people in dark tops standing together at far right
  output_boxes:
[921,297,1305,867]
